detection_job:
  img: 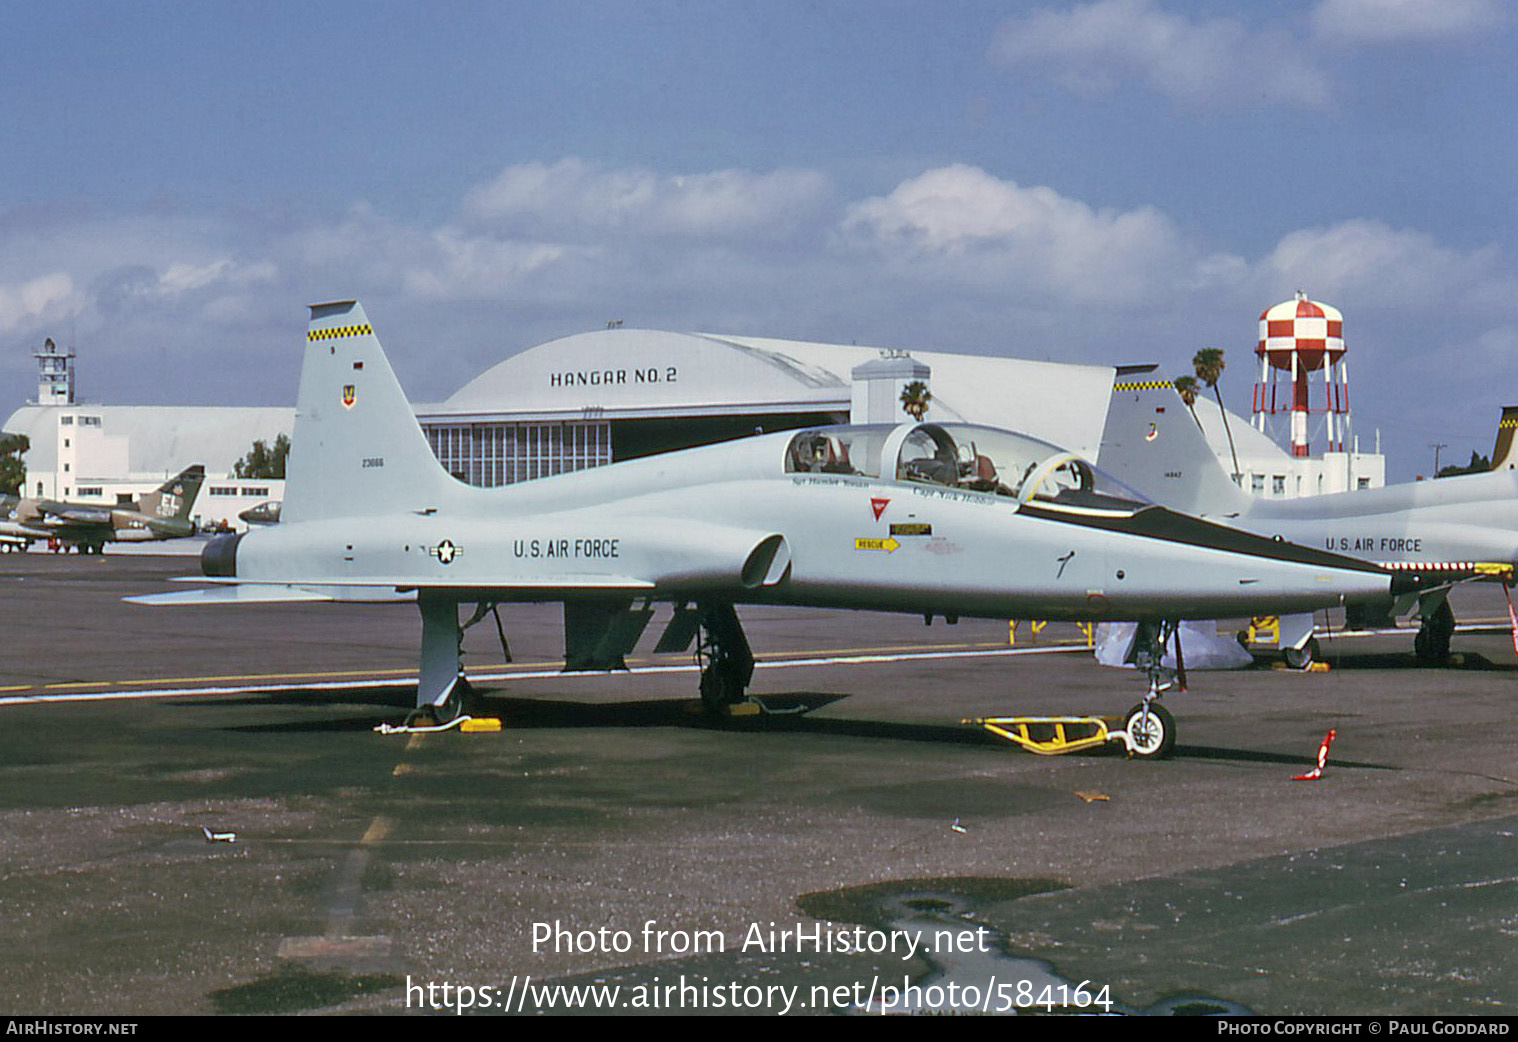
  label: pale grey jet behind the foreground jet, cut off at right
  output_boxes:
[1098,366,1518,665]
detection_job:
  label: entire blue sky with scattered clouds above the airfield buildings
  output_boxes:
[0,0,1518,480]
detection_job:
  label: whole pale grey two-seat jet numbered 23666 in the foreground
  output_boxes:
[135,301,1394,755]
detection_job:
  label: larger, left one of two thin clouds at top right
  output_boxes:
[991,0,1331,109]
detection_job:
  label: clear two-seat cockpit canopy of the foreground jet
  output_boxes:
[785,424,1149,513]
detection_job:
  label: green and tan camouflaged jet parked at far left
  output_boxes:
[0,463,205,553]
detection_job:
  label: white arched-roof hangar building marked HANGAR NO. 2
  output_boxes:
[416,328,1114,486]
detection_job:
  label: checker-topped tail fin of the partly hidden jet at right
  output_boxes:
[1096,366,1252,516]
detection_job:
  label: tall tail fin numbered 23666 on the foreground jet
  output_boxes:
[282,301,454,531]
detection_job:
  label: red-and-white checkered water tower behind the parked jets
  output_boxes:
[1251,290,1350,457]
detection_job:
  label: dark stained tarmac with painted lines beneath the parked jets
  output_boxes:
[0,551,1518,1016]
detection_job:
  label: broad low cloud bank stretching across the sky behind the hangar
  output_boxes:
[0,161,1518,440]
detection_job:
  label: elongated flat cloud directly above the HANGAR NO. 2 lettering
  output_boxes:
[463,158,830,238]
